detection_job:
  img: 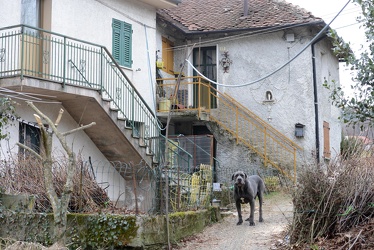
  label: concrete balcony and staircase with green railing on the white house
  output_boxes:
[0,25,175,170]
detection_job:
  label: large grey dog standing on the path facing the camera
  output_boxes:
[232,171,265,226]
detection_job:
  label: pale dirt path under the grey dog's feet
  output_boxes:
[175,193,292,250]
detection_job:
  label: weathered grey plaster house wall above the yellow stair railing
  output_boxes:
[169,28,341,168]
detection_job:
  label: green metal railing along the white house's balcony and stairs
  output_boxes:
[0,25,184,166]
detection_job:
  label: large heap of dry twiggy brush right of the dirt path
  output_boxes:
[291,158,374,249]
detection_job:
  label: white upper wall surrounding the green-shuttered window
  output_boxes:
[52,0,156,111]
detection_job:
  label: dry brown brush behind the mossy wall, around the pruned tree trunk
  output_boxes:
[0,157,111,212]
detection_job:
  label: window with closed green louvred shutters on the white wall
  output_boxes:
[112,19,132,68]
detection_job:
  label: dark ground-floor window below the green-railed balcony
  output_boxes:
[19,122,40,154]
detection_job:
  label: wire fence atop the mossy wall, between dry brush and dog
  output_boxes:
[91,159,213,213]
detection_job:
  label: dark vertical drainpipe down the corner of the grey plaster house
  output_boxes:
[312,35,326,164]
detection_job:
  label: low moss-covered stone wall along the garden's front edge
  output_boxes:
[0,207,221,249]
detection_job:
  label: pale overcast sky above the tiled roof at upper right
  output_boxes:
[286,0,365,96]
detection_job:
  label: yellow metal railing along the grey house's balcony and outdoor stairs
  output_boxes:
[157,77,300,181]
